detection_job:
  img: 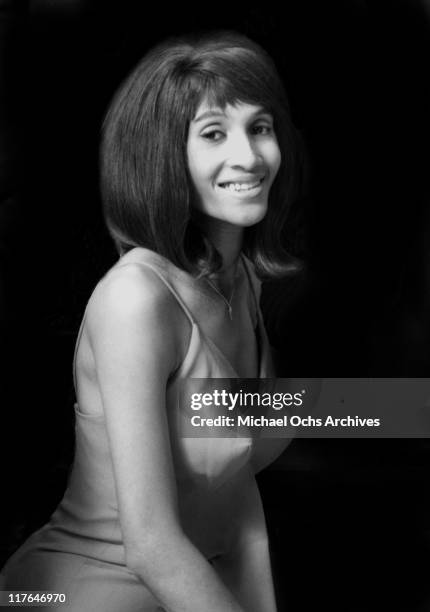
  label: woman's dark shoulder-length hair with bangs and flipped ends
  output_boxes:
[100,31,297,278]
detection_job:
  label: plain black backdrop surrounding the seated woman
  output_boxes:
[0,0,430,612]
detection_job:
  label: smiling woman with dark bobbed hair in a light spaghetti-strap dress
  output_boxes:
[2,32,295,612]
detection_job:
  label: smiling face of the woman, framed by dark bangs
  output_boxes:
[187,101,281,227]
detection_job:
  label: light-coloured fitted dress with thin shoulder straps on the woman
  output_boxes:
[0,249,288,612]
